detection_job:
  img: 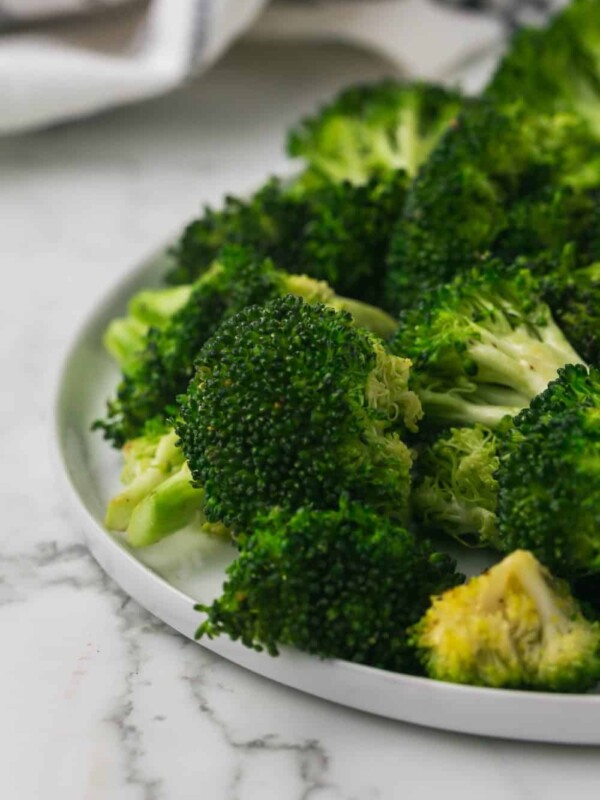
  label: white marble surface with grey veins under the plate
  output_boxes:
[0,46,600,800]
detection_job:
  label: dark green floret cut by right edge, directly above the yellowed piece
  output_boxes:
[497,405,600,578]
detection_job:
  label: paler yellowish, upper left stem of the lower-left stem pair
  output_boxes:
[104,431,185,531]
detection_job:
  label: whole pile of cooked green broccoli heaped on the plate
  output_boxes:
[94,0,600,692]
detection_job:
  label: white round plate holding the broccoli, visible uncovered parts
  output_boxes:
[55,244,600,744]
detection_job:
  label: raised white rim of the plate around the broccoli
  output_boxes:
[50,240,600,745]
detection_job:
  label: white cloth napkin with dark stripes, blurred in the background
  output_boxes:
[0,0,562,133]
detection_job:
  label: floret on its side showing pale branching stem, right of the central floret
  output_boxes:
[390,263,581,428]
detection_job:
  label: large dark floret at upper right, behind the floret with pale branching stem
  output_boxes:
[387,103,600,307]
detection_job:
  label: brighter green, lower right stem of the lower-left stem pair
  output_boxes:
[127,464,204,547]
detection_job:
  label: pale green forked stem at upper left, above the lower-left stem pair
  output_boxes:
[103,286,192,373]
